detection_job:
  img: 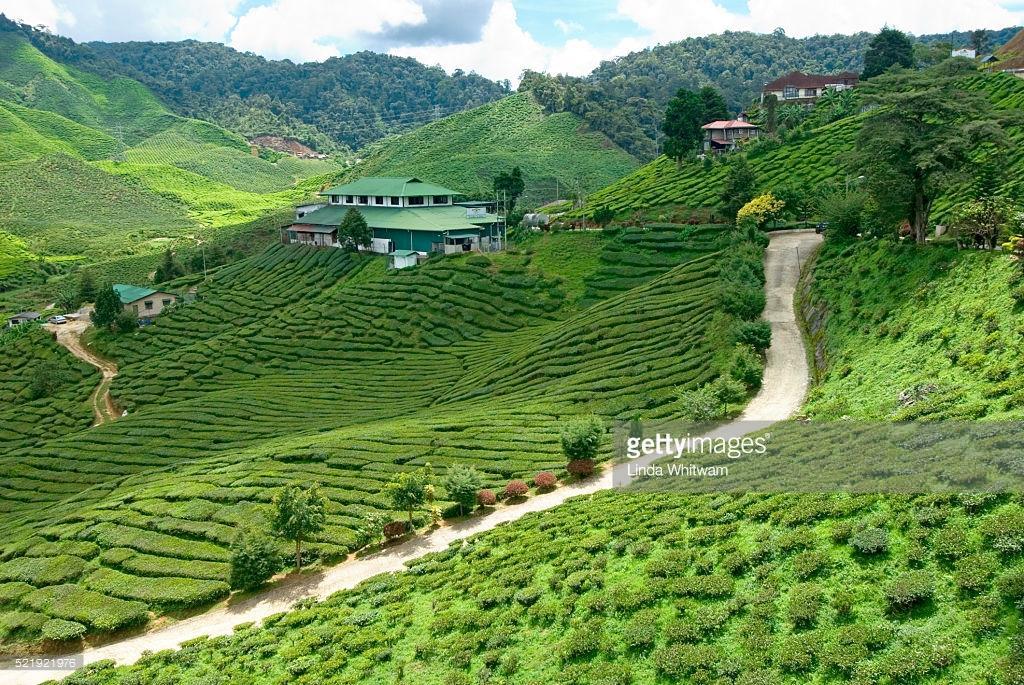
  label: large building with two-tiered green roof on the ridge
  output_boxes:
[283,176,504,268]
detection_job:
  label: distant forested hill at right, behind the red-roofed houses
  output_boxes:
[520,27,1019,159]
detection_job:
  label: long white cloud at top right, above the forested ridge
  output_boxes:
[617,0,1024,43]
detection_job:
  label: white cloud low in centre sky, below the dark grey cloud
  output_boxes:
[389,0,632,86]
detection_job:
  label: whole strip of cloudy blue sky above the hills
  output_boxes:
[6,0,1024,86]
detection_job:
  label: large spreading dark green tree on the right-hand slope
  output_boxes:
[851,61,1009,243]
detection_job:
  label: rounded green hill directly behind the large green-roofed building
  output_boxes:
[351,93,637,205]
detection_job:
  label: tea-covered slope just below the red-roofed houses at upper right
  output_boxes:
[585,69,1024,216]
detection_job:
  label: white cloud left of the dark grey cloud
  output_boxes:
[228,0,427,61]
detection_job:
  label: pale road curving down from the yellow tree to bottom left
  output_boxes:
[4,231,820,685]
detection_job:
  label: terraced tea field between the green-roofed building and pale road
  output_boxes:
[0,226,761,641]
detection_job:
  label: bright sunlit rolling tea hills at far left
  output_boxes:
[0,31,340,301]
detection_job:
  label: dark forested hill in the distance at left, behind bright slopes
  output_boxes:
[0,15,508,152]
